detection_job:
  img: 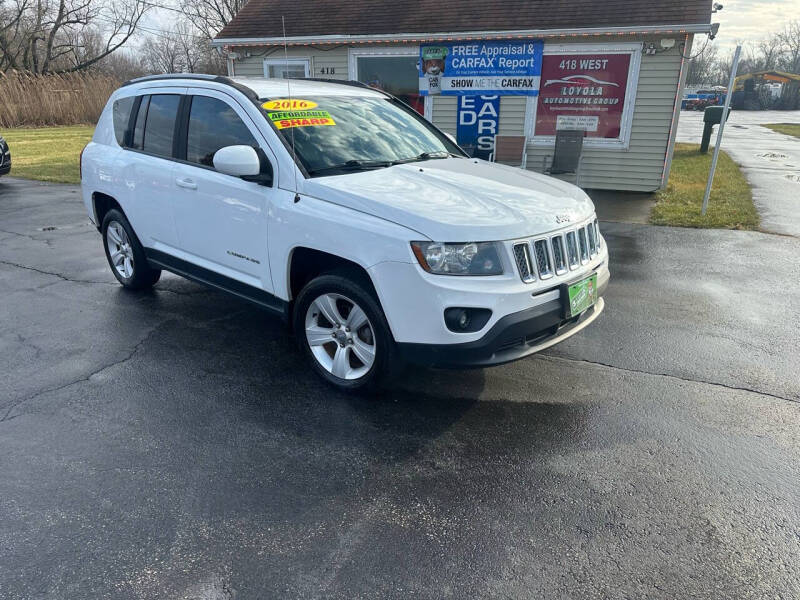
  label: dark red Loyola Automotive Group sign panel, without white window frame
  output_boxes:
[535,53,631,139]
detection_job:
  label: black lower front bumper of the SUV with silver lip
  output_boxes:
[397,279,608,368]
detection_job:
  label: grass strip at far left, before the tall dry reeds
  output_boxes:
[0,125,94,183]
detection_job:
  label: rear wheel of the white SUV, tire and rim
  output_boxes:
[101,209,161,290]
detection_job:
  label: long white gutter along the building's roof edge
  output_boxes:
[211,23,711,46]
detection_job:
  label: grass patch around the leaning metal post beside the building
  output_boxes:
[650,144,759,229]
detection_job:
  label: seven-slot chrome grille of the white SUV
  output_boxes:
[512,219,602,283]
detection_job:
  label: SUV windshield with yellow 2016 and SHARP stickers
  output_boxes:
[262,96,463,176]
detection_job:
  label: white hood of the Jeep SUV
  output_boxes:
[304,158,594,242]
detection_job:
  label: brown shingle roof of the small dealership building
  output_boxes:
[217,0,711,39]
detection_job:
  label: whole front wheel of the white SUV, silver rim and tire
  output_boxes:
[294,274,395,390]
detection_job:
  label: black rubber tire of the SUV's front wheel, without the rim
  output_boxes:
[292,270,397,391]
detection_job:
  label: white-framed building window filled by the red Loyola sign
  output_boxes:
[531,43,641,148]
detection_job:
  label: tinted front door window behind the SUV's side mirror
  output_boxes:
[187,96,258,167]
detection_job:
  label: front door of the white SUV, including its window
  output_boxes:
[172,89,272,292]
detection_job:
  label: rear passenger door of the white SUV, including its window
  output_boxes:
[118,88,186,252]
